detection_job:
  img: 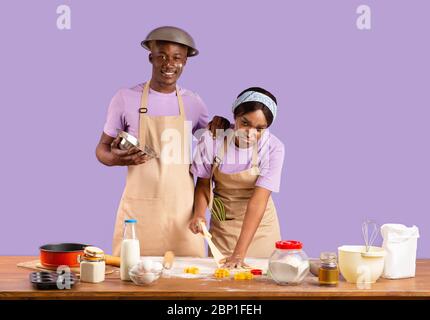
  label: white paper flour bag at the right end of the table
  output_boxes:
[381,224,420,279]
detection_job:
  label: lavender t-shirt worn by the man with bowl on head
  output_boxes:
[103,83,208,137]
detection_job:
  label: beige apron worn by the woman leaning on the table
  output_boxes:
[209,139,281,258]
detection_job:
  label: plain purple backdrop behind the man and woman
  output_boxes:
[0,0,430,258]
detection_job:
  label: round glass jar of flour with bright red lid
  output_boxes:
[269,240,310,285]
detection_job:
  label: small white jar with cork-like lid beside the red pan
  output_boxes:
[79,247,106,283]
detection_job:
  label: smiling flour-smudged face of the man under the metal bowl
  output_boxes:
[149,41,188,87]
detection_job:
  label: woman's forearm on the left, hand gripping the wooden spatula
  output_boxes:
[189,178,211,233]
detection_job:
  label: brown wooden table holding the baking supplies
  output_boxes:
[0,256,430,300]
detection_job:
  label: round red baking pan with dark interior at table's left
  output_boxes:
[39,243,89,268]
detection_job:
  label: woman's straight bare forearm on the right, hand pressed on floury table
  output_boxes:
[225,186,272,268]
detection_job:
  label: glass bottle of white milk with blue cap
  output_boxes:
[120,220,140,281]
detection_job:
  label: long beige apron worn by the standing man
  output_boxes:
[112,81,205,257]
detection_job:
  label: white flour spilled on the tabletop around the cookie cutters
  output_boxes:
[145,256,268,279]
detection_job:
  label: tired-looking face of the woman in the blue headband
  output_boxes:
[234,110,267,148]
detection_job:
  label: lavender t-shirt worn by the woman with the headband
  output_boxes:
[190,130,285,192]
